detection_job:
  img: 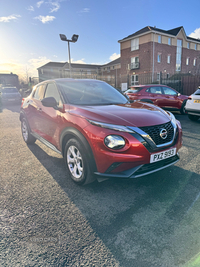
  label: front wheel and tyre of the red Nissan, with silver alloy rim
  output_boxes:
[64,138,95,185]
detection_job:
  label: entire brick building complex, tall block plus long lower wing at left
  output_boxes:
[38,26,200,88]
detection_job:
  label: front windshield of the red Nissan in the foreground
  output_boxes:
[58,80,128,105]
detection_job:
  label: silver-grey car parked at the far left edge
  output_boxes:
[0,87,22,104]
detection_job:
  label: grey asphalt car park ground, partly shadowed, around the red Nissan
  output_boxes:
[0,103,200,267]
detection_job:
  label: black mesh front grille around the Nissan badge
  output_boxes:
[140,122,174,145]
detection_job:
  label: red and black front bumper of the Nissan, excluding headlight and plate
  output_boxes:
[85,121,182,178]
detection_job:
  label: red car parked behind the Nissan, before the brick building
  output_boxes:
[124,84,188,114]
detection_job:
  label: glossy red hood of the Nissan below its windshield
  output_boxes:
[69,101,170,127]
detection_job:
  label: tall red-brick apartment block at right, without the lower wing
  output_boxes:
[118,26,200,85]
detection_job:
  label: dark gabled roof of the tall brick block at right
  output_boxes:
[118,26,200,43]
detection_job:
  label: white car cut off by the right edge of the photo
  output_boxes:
[185,86,200,121]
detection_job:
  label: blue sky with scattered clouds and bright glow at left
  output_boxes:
[0,0,200,81]
